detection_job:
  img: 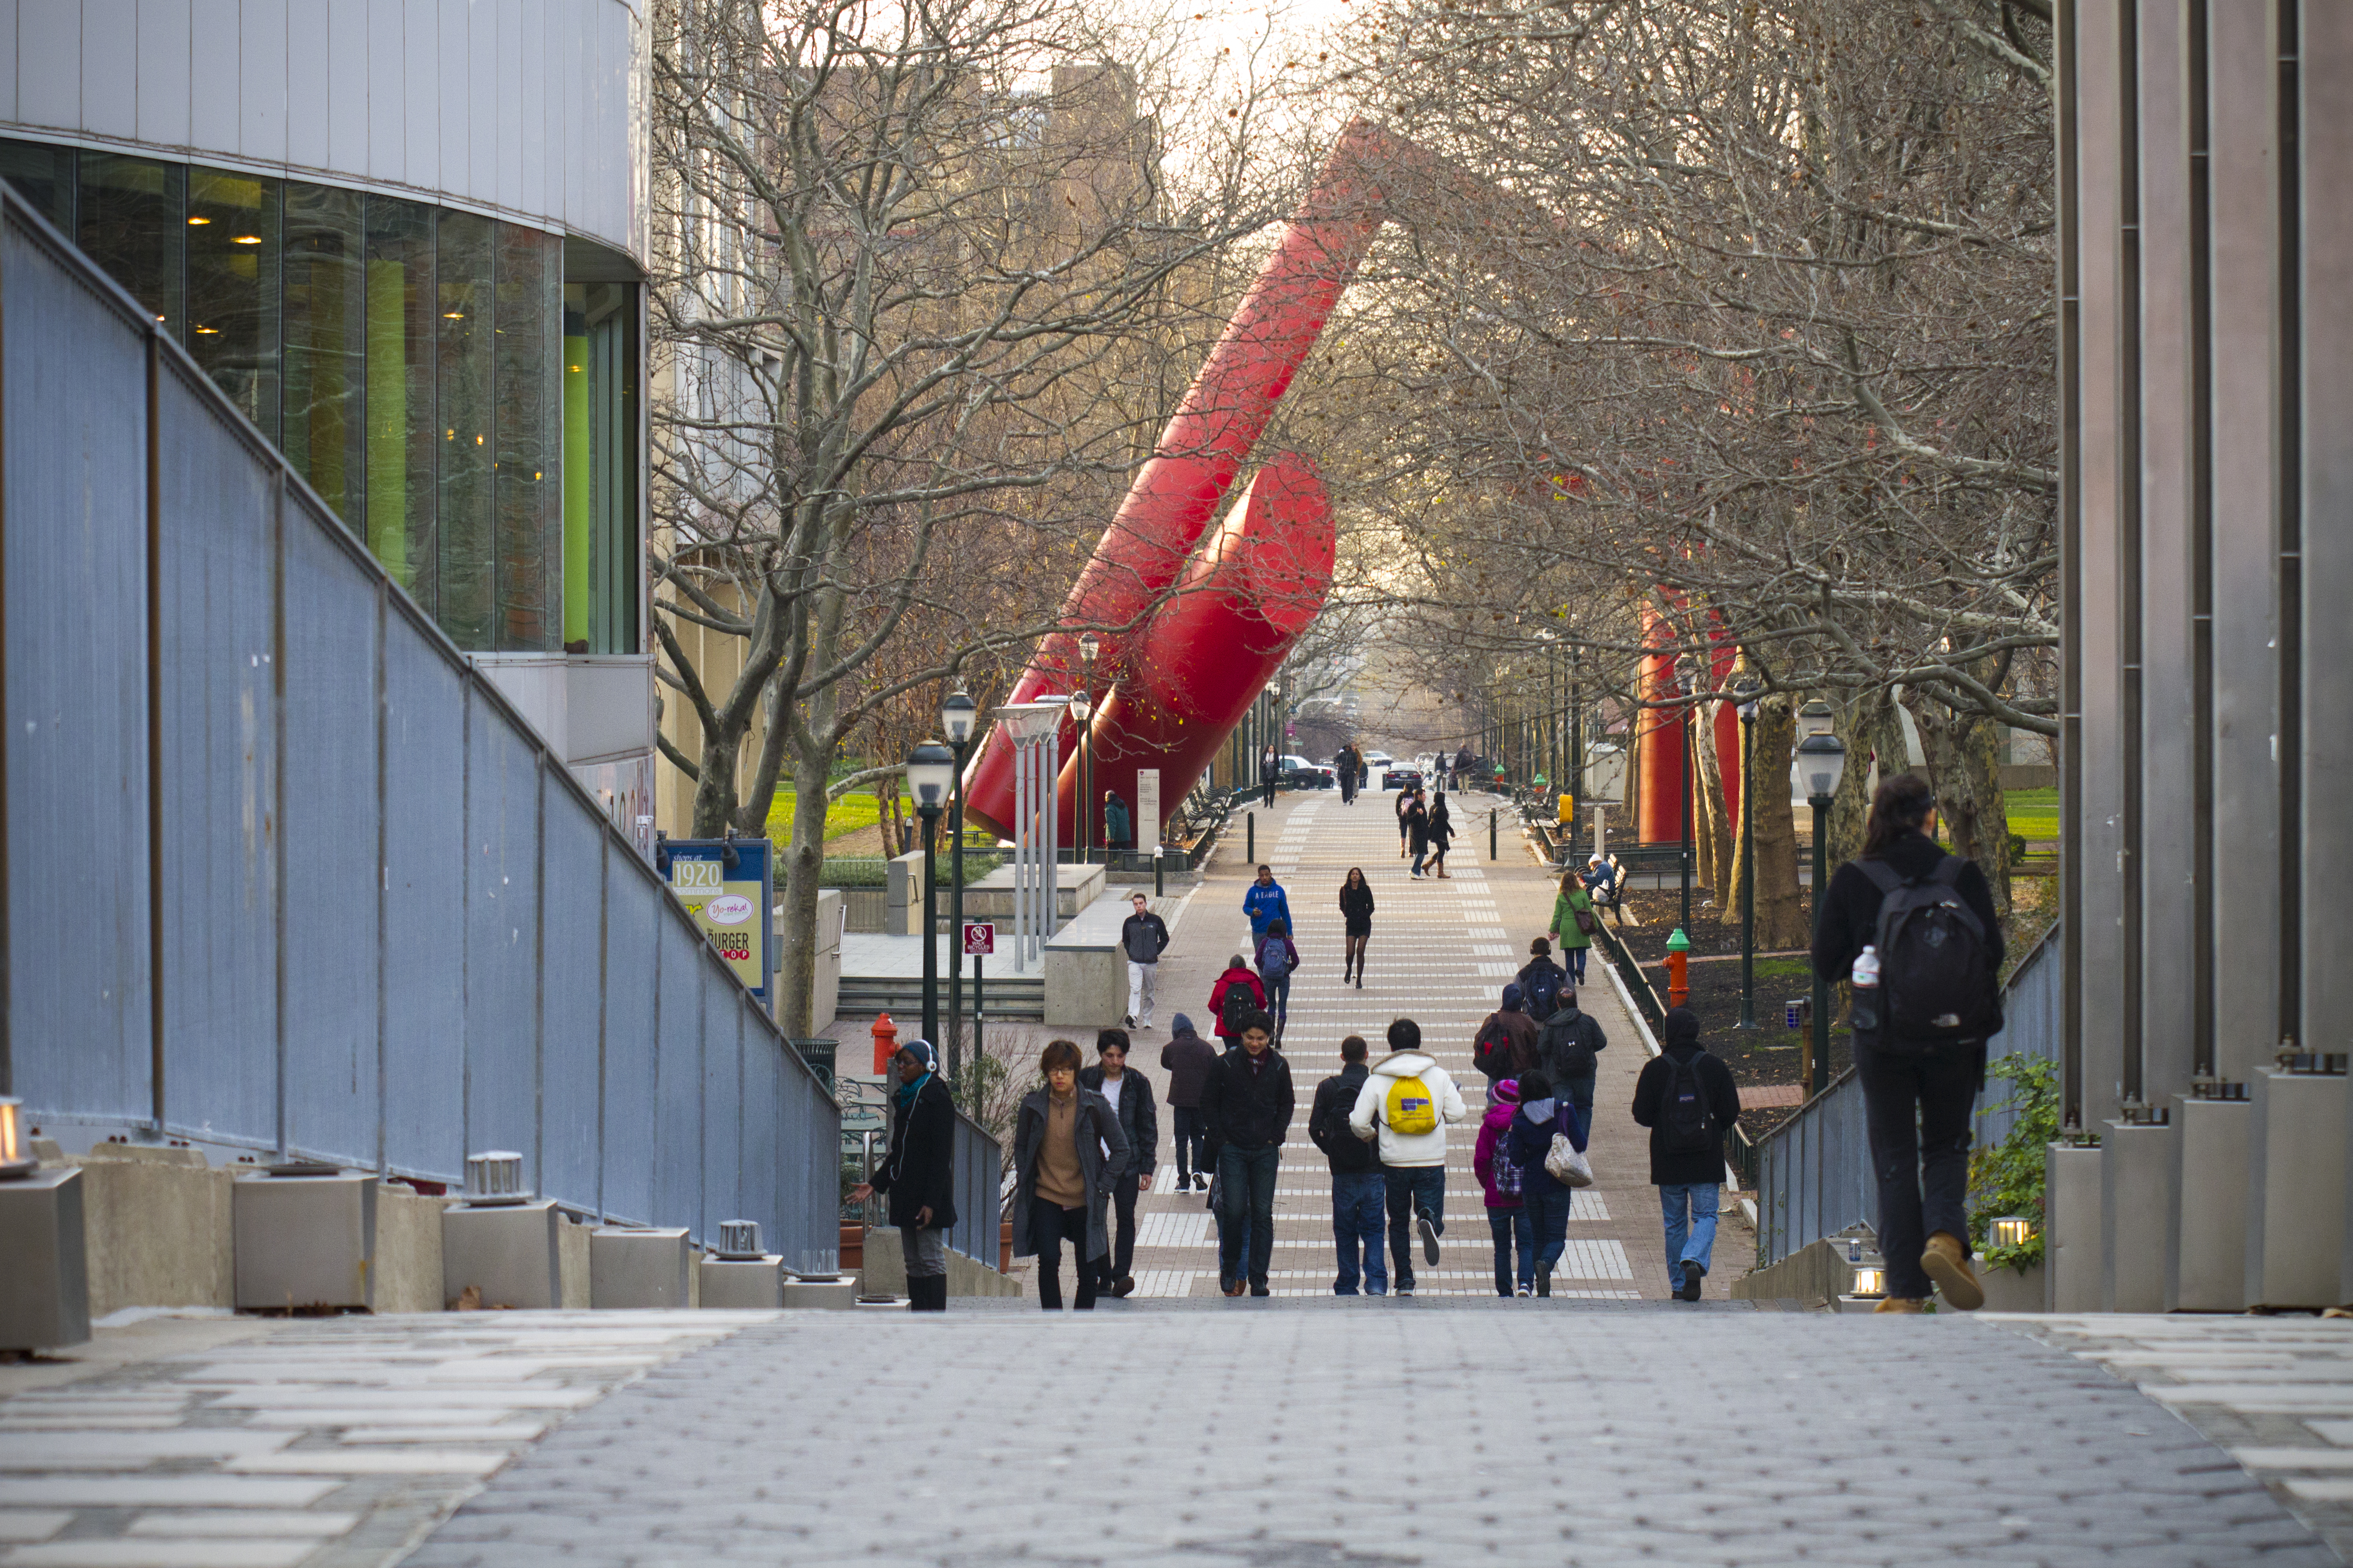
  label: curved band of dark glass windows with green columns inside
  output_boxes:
[0,141,642,654]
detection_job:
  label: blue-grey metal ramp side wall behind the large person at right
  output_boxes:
[1758,928,2061,1264]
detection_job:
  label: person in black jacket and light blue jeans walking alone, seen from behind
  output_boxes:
[1633,1008,1750,1302]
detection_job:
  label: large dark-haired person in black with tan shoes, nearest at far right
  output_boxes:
[1814,772,2002,1312]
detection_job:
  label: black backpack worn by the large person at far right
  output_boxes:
[1854,855,2002,1045]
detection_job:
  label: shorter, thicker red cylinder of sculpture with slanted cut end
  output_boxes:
[1059,452,1334,829]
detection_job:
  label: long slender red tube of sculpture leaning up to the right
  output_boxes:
[965,122,1409,834]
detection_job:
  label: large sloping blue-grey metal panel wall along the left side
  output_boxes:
[0,193,840,1269]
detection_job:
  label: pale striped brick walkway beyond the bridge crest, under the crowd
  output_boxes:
[1024,791,1755,1312]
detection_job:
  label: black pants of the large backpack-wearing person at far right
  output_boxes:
[1854,1043,1986,1299]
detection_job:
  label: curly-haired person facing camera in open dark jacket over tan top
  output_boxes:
[1014,1041,1127,1312]
